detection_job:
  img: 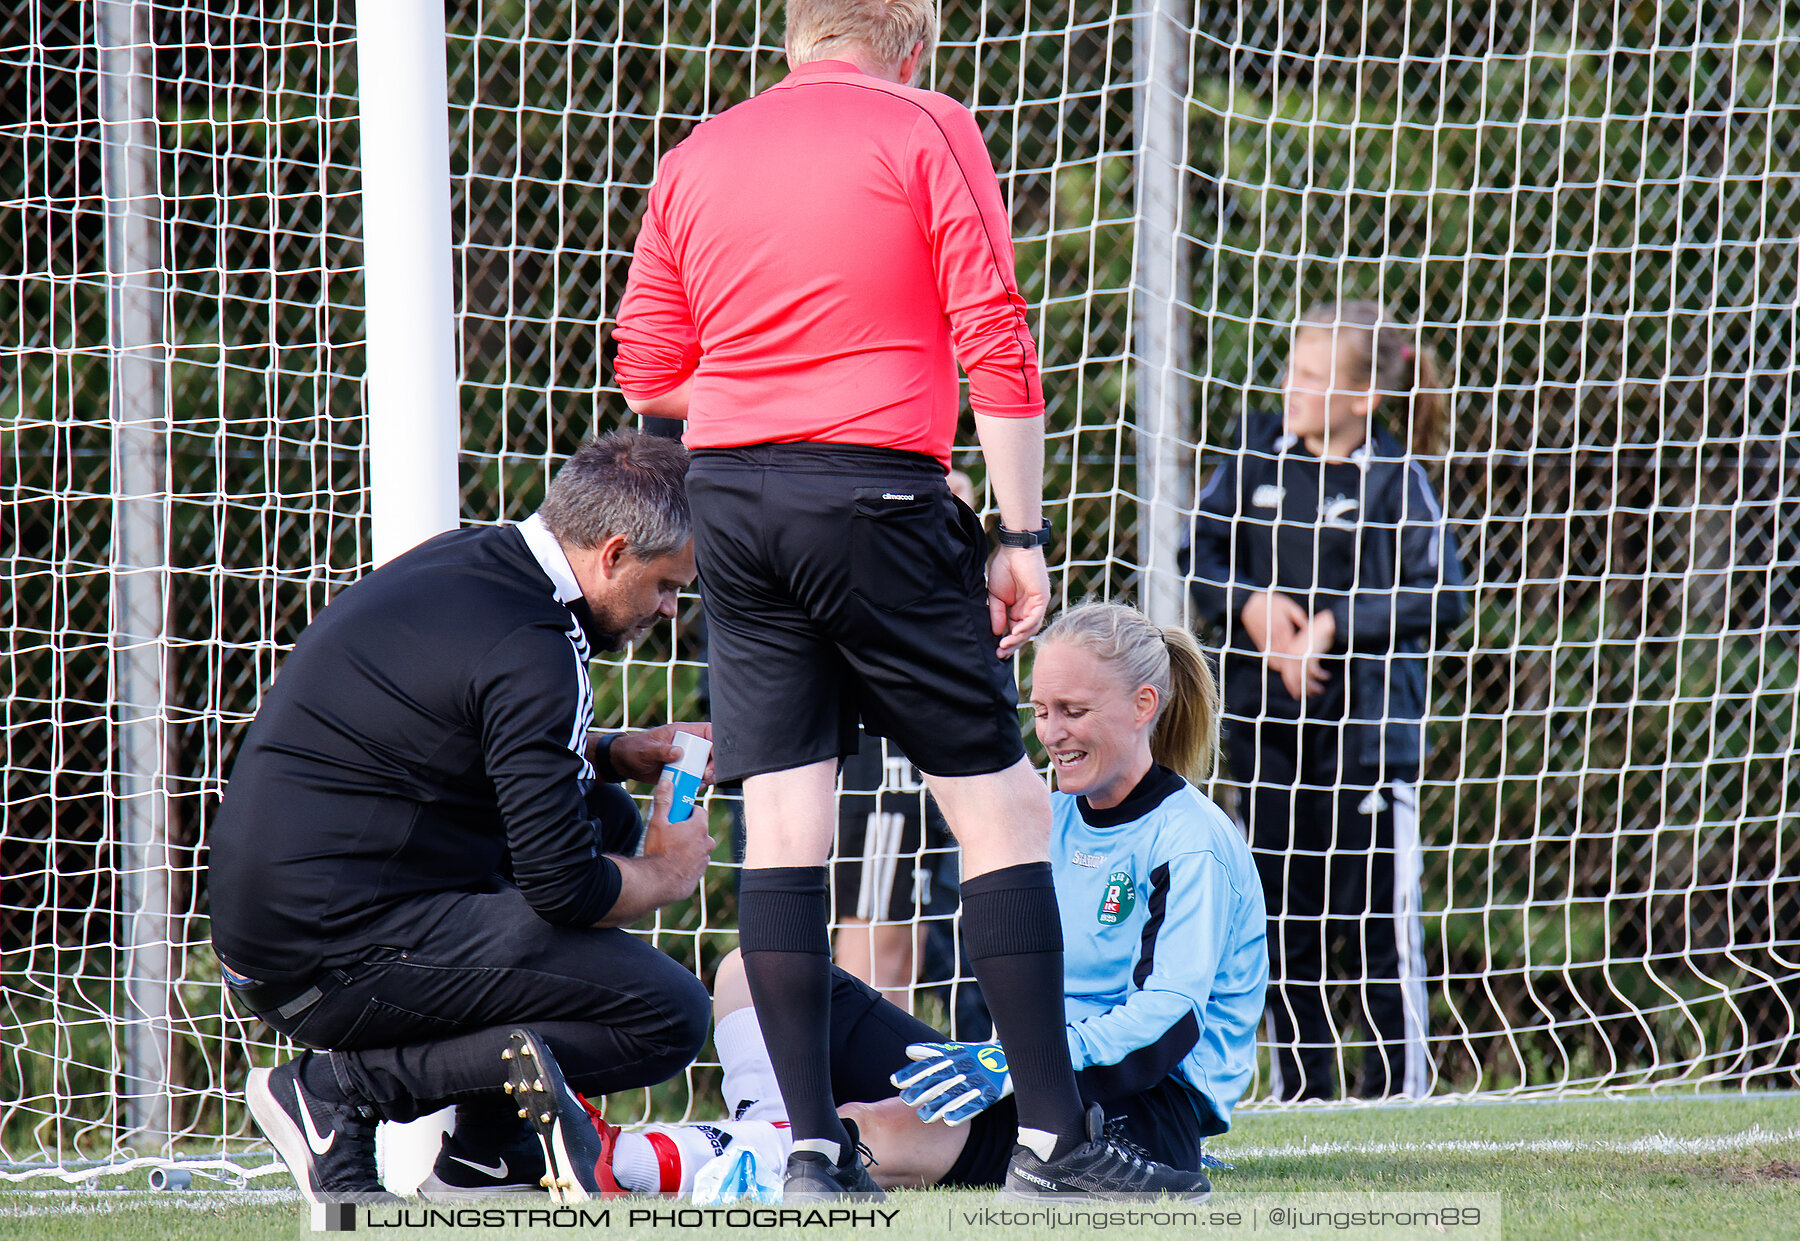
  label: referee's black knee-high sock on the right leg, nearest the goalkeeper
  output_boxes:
[963,861,1087,1158]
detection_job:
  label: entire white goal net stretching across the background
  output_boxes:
[0,0,1800,1178]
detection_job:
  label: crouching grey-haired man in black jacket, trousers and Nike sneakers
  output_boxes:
[209,432,713,1201]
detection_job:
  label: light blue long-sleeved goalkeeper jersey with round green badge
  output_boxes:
[1049,767,1269,1133]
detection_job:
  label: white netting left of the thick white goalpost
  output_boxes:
[0,4,369,1162]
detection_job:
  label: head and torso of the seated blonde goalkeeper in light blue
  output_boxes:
[1031,603,1269,1167]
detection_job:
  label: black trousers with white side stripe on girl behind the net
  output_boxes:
[1228,719,1427,1099]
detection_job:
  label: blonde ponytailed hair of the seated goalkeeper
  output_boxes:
[1037,602,1224,784]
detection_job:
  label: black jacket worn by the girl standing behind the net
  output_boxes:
[1183,414,1469,776]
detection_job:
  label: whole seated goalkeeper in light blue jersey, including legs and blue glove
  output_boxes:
[715,603,1269,1189]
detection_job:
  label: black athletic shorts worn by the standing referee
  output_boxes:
[688,443,1024,780]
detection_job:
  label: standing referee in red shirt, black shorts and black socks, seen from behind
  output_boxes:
[614,0,1204,1198]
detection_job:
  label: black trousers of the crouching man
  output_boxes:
[257,886,711,1120]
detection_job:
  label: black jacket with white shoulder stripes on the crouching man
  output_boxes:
[209,526,634,982]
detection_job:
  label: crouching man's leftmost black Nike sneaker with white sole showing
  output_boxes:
[245,1052,400,1203]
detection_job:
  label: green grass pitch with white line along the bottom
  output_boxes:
[0,1093,1800,1241]
